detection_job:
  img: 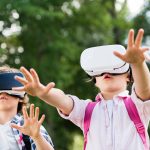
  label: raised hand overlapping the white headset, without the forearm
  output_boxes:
[114,29,149,64]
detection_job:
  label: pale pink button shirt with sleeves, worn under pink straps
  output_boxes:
[58,90,150,150]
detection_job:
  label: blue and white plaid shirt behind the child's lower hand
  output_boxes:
[11,113,53,150]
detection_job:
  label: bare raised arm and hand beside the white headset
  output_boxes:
[114,29,150,101]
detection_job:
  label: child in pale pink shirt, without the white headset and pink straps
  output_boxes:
[14,29,150,150]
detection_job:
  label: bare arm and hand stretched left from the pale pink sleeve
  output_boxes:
[13,67,73,115]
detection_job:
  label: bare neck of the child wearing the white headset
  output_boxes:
[101,90,124,100]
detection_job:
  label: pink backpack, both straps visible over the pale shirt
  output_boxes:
[83,96,148,150]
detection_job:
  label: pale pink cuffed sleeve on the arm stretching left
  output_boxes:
[57,95,90,129]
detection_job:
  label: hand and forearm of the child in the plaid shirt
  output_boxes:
[11,104,54,150]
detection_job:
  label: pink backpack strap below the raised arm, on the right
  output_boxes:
[123,97,148,150]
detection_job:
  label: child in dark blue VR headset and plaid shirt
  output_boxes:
[0,66,54,150]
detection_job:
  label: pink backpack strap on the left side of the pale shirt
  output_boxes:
[83,102,98,150]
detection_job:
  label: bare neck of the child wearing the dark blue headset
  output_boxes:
[0,110,17,124]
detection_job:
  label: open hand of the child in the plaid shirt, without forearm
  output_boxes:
[11,104,45,140]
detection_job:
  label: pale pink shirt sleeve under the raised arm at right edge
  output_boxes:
[131,85,150,127]
